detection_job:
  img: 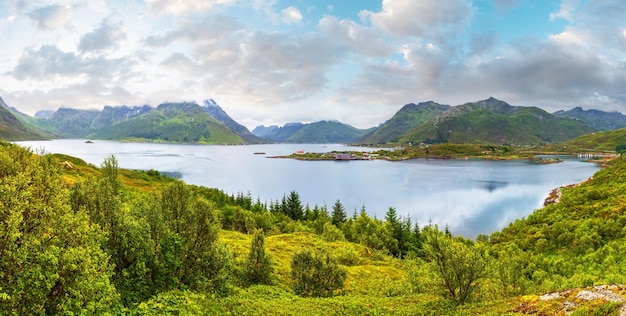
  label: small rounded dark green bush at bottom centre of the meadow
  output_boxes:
[291,250,346,297]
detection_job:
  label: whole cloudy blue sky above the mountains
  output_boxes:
[0,0,626,129]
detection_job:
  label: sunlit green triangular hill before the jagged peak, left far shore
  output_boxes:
[88,103,244,144]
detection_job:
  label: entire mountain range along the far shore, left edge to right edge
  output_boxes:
[0,98,626,145]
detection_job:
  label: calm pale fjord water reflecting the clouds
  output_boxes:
[18,140,598,238]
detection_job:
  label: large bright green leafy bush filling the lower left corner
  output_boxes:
[0,144,119,314]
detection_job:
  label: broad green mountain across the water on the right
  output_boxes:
[358,98,594,145]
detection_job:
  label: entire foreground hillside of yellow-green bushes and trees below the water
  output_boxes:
[0,143,626,315]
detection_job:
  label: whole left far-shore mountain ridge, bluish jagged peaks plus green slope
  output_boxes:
[26,102,245,144]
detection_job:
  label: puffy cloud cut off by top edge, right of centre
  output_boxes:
[360,0,473,41]
